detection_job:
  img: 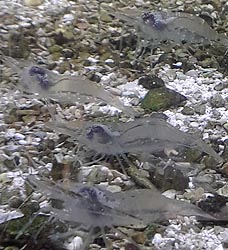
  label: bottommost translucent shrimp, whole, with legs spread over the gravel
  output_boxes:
[21,176,217,249]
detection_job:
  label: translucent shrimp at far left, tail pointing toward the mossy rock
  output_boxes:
[3,57,136,116]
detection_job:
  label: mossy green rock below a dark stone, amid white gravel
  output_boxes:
[141,87,186,111]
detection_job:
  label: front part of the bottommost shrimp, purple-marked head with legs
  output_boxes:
[27,176,142,250]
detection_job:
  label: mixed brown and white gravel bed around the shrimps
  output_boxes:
[0,0,228,250]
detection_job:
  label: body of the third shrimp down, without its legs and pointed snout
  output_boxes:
[84,118,222,162]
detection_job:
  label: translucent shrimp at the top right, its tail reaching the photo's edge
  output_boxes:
[112,9,228,55]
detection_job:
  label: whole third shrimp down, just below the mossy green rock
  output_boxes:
[48,117,223,174]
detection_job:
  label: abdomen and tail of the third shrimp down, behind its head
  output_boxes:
[117,118,223,162]
